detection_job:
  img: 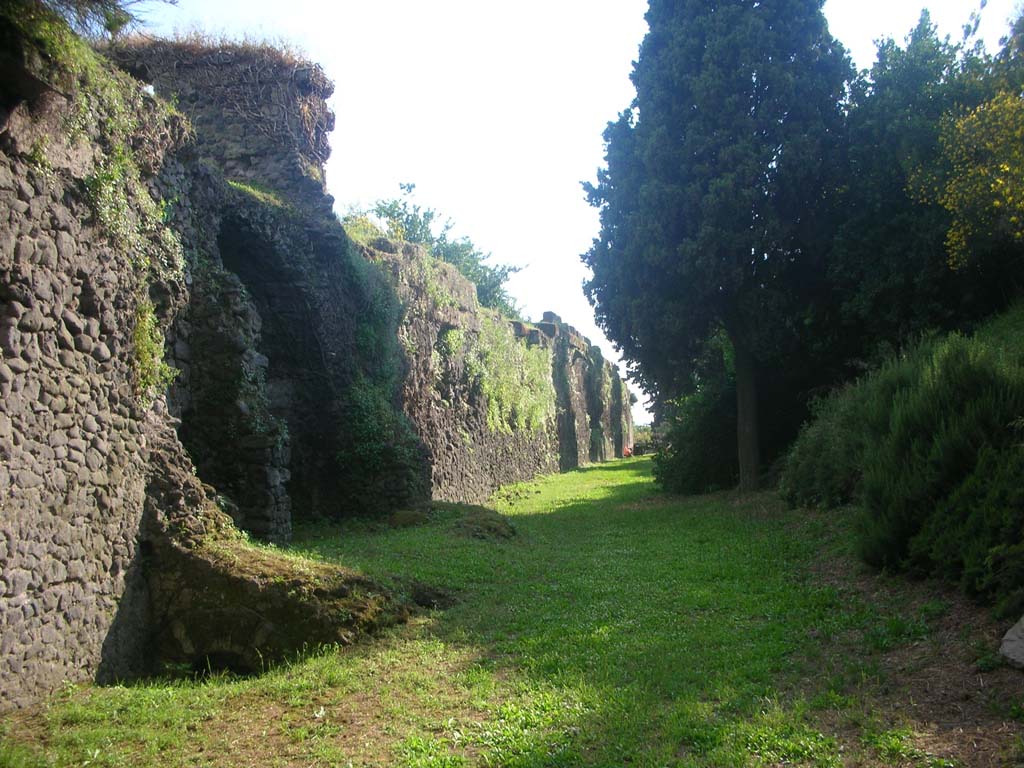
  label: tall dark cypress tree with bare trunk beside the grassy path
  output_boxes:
[583,0,852,489]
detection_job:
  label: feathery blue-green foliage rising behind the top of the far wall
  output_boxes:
[370,184,519,317]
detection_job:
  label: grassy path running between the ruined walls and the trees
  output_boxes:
[0,459,1024,768]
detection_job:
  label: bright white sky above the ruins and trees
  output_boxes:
[142,0,1016,423]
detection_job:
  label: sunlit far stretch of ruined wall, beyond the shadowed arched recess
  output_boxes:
[366,256,633,502]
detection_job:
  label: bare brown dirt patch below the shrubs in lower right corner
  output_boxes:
[812,528,1024,768]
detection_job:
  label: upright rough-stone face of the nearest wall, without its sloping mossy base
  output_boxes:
[0,13,192,707]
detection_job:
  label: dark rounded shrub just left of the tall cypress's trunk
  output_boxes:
[654,378,739,494]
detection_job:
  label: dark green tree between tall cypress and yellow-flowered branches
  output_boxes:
[828,11,992,348]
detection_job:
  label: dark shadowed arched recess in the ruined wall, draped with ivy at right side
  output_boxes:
[178,188,429,528]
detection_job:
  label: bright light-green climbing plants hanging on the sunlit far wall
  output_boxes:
[466,311,555,434]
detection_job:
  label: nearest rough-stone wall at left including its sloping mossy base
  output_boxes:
[0,7,403,710]
